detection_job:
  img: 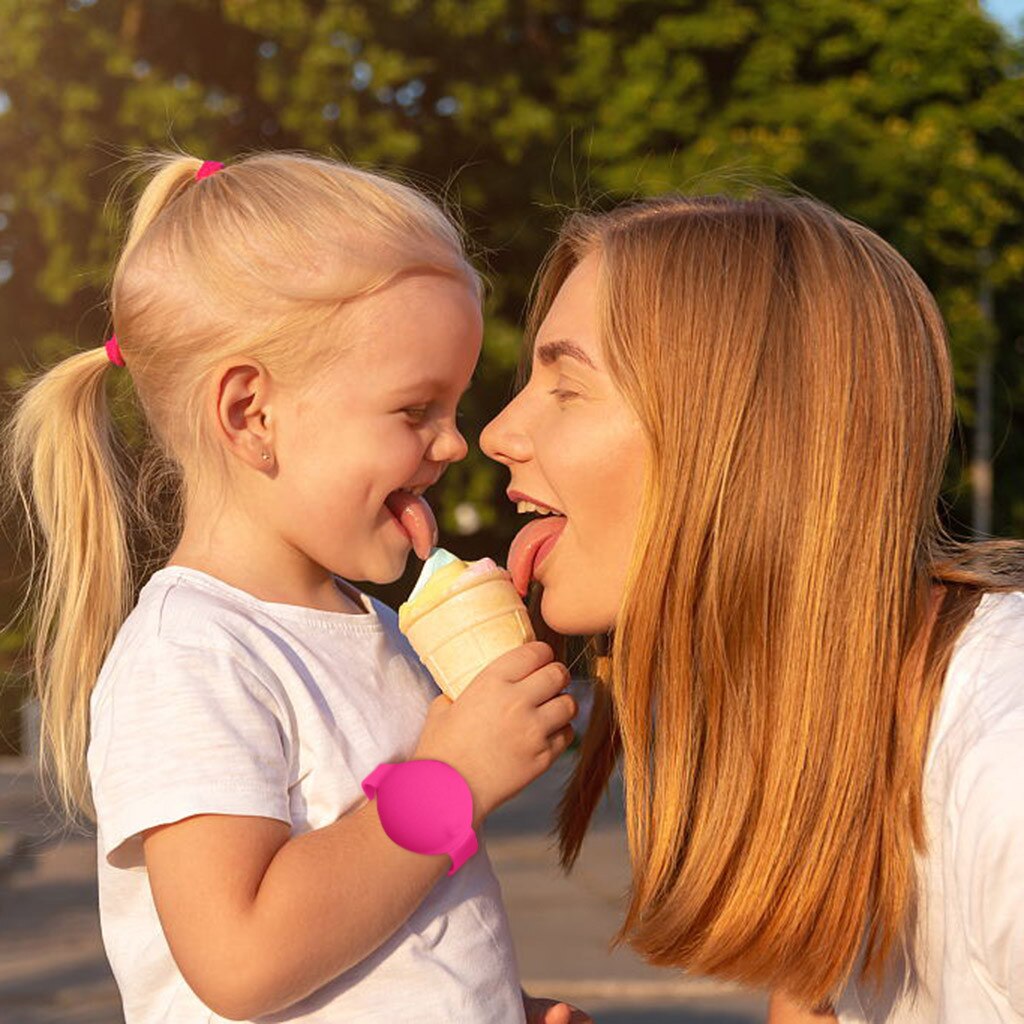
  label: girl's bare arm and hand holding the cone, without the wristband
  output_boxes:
[142,642,577,1019]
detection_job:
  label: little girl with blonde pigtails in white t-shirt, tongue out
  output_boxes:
[8,154,583,1024]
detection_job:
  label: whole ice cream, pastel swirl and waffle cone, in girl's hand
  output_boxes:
[398,548,535,700]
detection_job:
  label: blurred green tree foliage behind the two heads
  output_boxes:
[0,0,1024,622]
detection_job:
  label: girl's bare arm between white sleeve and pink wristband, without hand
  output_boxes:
[143,803,451,1020]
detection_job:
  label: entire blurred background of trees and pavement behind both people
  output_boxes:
[0,8,1024,1024]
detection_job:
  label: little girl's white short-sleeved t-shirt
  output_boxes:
[88,566,525,1024]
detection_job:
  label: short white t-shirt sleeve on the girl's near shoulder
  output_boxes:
[89,641,291,867]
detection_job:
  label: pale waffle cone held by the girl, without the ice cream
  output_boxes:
[402,569,535,700]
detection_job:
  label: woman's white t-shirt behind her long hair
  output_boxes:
[837,592,1024,1024]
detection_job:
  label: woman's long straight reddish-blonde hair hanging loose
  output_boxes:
[520,191,1024,1005]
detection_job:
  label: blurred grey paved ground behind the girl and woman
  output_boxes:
[0,759,765,1024]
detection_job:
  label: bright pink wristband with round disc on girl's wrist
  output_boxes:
[362,760,477,876]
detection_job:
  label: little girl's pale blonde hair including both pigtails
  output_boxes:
[4,153,480,817]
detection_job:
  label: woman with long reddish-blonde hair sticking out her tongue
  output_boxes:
[481,194,1024,1024]
